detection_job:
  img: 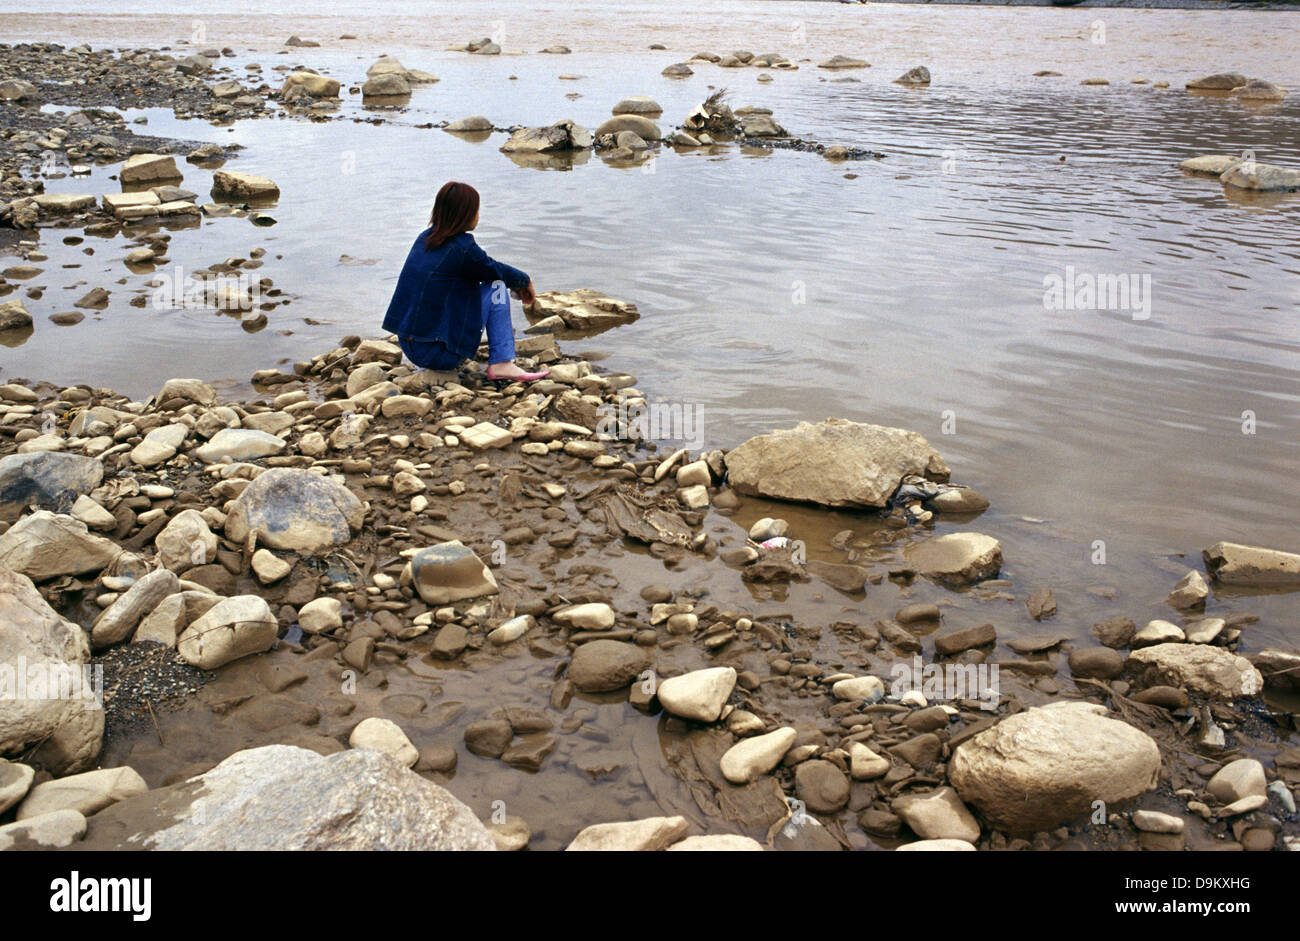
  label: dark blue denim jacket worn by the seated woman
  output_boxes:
[384,229,530,359]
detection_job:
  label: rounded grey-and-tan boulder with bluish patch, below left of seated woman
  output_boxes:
[225,468,365,552]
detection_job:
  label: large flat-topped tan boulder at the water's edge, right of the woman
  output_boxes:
[727,419,949,507]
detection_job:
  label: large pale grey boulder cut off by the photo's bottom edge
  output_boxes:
[87,745,495,851]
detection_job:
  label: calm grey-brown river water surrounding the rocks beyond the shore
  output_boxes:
[0,7,1300,670]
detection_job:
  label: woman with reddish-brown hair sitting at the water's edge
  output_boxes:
[384,182,550,382]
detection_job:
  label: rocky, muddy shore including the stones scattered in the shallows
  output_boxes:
[0,33,1300,850]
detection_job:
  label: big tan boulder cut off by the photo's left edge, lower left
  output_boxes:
[0,567,104,773]
